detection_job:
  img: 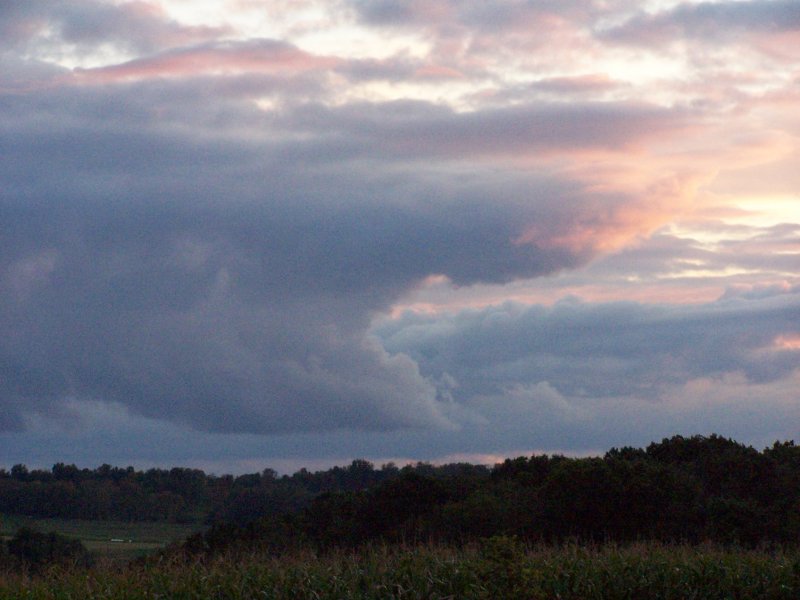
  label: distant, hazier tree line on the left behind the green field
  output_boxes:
[0,459,424,523]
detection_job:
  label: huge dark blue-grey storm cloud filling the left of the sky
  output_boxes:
[0,72,626,433]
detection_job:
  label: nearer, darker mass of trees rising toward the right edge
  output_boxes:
[184,435,800,554]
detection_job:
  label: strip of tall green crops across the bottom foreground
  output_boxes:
[0,539,800,600]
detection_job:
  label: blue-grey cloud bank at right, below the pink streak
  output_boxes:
[376,288,800,401]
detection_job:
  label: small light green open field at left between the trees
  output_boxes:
[0,515,201,560]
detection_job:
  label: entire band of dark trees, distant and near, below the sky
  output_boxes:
[0,435,800,553]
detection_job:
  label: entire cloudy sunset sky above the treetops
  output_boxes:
[0,0,800,473]
